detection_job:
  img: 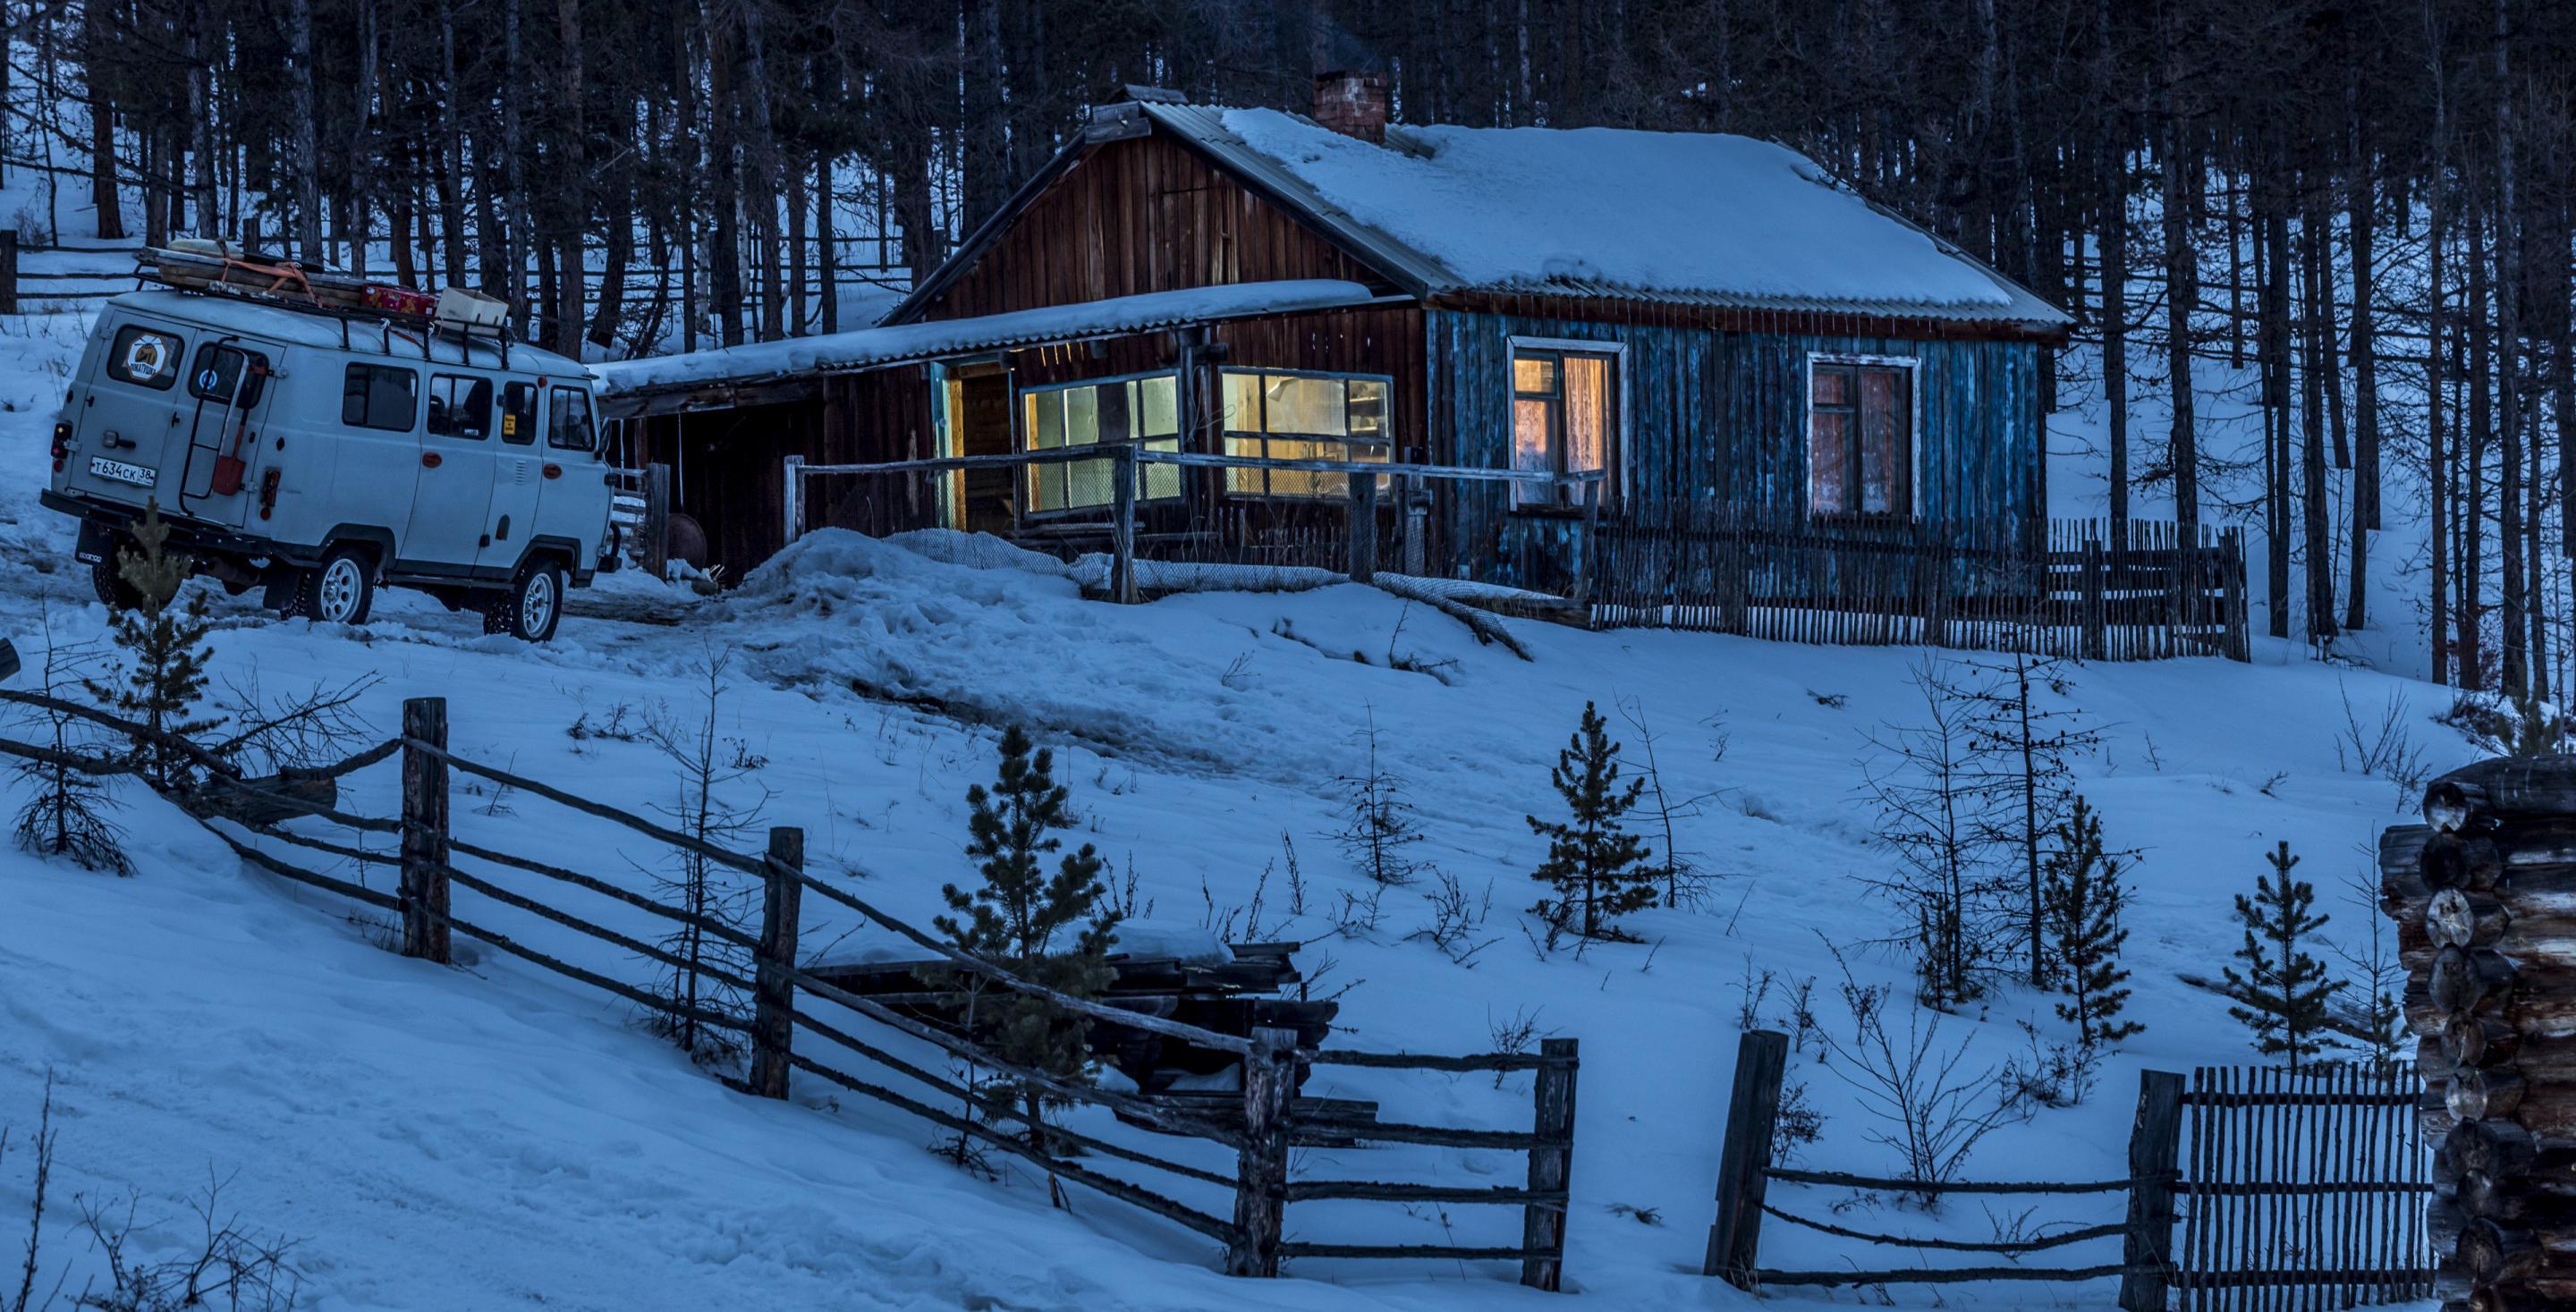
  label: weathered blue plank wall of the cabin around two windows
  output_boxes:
[1425,309,2043,588]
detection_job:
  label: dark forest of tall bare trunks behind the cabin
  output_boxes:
[5,0,2576,696]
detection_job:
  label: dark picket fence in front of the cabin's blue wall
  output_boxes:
[1592,505,2249,660]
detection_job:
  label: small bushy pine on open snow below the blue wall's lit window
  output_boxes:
[1528,701,1662,938]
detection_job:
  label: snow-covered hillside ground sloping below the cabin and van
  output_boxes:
[0,317,2442,1312]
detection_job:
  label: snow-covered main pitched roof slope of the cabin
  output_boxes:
[1136,103,2072,327]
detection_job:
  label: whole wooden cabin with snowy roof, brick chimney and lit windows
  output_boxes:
[603,75,2069,590]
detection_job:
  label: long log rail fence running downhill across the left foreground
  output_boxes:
[0,690,1579,1289]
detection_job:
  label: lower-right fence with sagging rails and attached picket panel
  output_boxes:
[1703,1031,2429,1312]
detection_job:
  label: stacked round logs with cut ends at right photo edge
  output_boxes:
[2380,755,2576,1312]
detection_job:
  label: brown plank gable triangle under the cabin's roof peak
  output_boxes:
[922,137,1384,319]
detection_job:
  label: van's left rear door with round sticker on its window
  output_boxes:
[62,312,196,513]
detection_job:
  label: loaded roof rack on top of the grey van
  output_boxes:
[134,237,530,368]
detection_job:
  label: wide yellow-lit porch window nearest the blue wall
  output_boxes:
[1224,368,1394,500]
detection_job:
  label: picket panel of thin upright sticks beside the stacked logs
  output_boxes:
[2172,1064,2435,1312]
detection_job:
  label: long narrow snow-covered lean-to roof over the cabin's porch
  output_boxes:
[590,278,1376,397]
